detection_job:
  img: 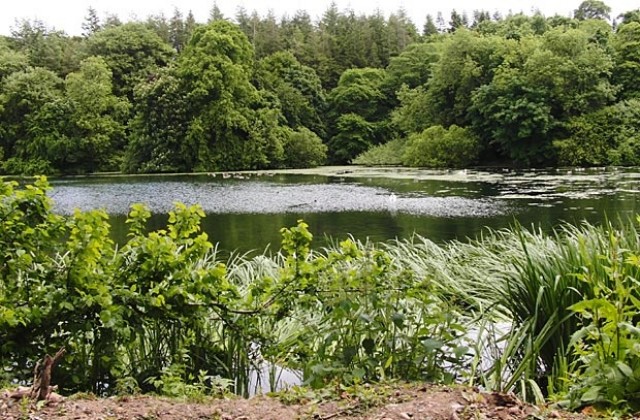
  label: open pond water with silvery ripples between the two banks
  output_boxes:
[51,167,640,252]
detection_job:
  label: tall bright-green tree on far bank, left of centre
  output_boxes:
[177,20,281,170]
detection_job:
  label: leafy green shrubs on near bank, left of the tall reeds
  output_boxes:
[0,179,467,397]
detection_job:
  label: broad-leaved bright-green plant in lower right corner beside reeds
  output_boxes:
[567,230,640,412]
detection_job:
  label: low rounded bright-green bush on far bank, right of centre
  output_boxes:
[402,125,480,168]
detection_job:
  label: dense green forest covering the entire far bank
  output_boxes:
[0,0,640,174]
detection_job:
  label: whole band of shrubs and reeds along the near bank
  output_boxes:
[0,178,640,413]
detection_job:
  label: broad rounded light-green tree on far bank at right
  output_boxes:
[470,28,615,165]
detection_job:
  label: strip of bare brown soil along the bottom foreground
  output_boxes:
[0,384,588,420]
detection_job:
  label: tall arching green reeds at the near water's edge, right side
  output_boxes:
[387,218,640,398]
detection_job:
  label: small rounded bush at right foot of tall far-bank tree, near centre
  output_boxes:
[284,127,327,168]
